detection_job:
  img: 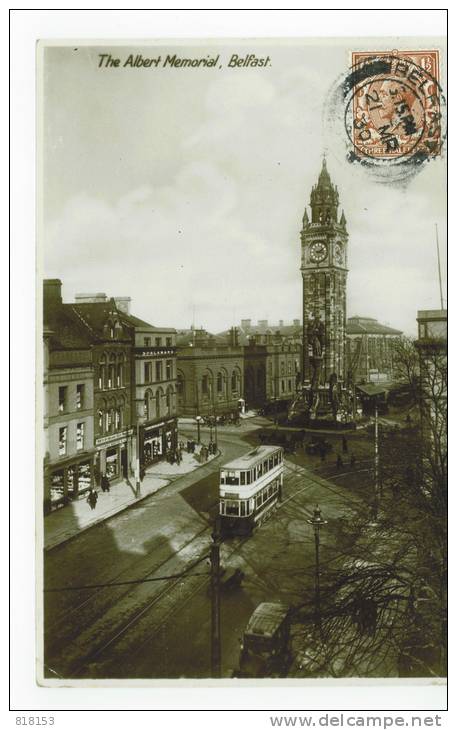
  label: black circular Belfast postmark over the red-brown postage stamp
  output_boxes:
[324,51,446,181]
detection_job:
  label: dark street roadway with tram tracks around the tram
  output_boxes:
[45,418,374,679]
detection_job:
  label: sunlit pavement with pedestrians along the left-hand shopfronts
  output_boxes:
[44,447,215,550]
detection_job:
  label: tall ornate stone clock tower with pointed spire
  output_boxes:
[300,157,348,390]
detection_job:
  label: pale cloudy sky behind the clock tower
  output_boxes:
[39,38,446,334]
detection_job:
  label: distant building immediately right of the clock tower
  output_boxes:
[346,316,403,383]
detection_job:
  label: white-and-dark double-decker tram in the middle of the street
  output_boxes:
[219,446,284,535]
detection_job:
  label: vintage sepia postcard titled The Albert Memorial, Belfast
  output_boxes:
[37,36,447,687]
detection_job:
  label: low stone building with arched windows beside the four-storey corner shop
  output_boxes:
[177,328,244,417]
